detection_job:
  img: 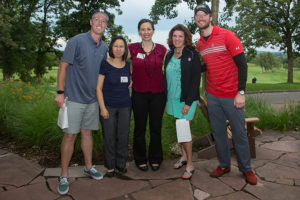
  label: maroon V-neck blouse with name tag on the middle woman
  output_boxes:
[128,43,167,93]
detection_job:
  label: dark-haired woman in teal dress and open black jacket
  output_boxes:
[164,24,204,179]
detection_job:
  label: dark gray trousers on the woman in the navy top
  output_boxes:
[101,107,131,169]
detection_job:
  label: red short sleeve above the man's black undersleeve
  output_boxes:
[226,31,244,57]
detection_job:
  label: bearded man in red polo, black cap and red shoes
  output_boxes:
[194,4,257,185]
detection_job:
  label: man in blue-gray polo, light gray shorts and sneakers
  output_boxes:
[55,9,108,195]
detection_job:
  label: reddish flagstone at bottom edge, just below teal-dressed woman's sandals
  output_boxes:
[132,179,194,200]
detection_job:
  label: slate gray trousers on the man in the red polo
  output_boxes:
[206,93,251,172]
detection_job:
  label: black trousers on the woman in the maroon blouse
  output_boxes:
[132,90,166,165]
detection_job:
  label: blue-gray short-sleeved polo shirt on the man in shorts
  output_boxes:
[61,32,107,104]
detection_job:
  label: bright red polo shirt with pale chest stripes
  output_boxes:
[197,26,244,98]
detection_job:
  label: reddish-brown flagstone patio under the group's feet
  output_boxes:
[0,130,300,200]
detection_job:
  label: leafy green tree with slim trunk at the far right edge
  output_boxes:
[232,0,300,83]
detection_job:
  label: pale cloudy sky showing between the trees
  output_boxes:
[59,0,278,51]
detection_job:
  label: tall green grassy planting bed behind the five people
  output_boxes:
[0,81,300,161]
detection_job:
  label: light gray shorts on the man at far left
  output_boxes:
[63,101,99,134]
